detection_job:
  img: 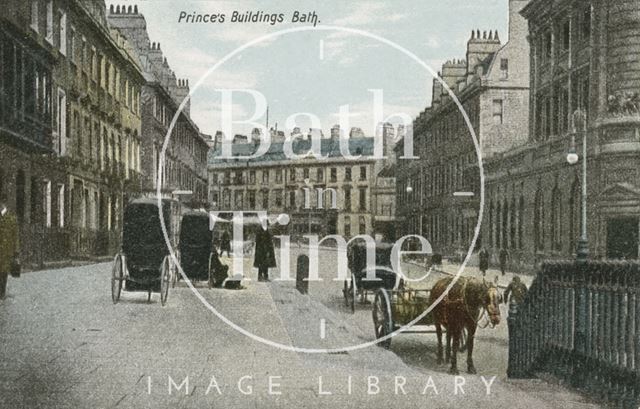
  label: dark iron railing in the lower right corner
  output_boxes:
[507,261,640,408]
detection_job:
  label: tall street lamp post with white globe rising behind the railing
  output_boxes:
[567,109,589,261]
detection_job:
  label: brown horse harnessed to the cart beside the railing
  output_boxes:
[430,277,500,374]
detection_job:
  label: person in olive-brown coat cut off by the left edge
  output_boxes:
[0,198,20,300]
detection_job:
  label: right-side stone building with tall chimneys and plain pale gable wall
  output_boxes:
[395,0,529,256]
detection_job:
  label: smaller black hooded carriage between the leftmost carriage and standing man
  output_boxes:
[176,210,228,288]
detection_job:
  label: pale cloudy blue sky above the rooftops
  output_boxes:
[107,0,508,135]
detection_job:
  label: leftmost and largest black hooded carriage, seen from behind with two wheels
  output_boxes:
[111,198,180,306]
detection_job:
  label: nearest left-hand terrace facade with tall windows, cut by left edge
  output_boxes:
[0,0,144,264]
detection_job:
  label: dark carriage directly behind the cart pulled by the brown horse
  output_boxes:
[342,242,403,312]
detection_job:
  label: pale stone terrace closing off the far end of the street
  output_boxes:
[209,127,394,238]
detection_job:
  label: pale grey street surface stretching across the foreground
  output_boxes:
[0,252,598,409]
